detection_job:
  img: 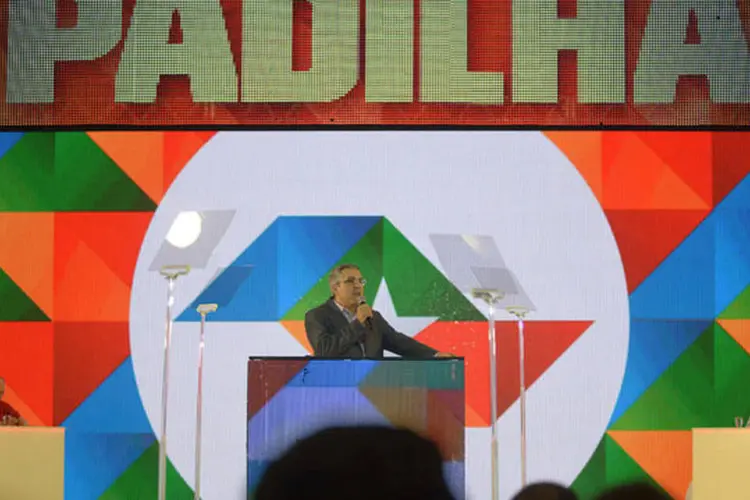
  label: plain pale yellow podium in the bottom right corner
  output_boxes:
[692,428,750,500]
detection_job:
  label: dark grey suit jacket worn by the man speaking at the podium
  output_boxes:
[305,299,437,359]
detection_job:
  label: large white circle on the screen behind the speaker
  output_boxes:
[130,131,629,500]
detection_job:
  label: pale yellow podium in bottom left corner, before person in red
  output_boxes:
[0,427,65,500]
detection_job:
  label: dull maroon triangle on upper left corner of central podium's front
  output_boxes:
[247,359,307,420]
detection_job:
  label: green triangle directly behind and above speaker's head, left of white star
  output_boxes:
[282,220,383,321]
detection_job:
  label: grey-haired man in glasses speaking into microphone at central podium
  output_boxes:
[305,264,452,359]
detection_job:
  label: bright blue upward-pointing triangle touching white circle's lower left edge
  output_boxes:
[62,356,152,434]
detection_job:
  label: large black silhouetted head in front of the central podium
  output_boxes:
[255,427,453,500]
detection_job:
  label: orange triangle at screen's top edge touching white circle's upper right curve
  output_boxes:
[544,131,603,203]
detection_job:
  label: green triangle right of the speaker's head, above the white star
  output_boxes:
[383,220,485,321]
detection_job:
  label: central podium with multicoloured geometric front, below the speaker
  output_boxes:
[247,357,466,500]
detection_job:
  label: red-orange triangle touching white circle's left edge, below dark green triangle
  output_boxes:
[55,212,154,286]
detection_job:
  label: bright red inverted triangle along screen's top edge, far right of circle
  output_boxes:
[637,132,713,206]
